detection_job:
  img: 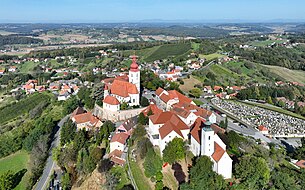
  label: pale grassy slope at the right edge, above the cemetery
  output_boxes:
[265,65,305,84]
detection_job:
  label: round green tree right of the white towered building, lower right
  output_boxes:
[235,155,270,189]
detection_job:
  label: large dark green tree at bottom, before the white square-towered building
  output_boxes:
[181,156,226,190]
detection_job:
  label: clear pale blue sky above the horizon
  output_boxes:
[0,0,305,23]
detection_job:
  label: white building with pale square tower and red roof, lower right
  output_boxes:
[190,118,232,179]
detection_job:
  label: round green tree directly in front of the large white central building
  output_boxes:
[163,137,185,164]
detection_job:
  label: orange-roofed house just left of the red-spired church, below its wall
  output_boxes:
[72,112,103,131]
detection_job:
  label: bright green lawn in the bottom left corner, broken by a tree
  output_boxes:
[0,151,29,190]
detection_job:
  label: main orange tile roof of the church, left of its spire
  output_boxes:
[110,80,139,97]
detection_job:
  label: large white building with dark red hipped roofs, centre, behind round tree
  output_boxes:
[147,111,190,155]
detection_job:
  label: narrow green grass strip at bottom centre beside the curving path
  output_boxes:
[129,160,151,190]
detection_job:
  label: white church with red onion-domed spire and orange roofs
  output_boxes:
[102,56,140,112]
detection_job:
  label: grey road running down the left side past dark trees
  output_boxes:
[35,115,70,190]
